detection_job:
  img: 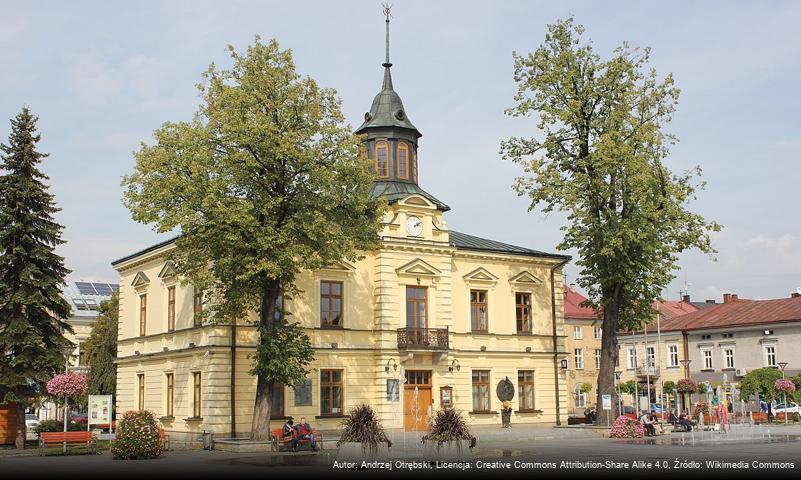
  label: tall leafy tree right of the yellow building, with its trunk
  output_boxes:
[501,19,719,423]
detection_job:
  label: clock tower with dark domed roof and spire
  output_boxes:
[355,8,450,241]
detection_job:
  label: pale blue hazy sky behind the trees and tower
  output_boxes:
[0,0,801,300]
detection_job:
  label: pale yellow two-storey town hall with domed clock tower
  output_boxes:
[113,22,569,441]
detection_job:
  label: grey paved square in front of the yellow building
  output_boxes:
[0,426,801,480]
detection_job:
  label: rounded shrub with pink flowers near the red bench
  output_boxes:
[111,410,161,460]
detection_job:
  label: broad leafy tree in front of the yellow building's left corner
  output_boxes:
[123,38,383,440]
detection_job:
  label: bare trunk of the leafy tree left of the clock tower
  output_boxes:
[250,279,281,441]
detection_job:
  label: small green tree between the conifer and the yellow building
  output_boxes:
[82,292,120,395]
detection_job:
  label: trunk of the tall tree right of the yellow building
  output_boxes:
[595,292,622,425]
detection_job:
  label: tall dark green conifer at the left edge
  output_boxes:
[0,107,72,448]
